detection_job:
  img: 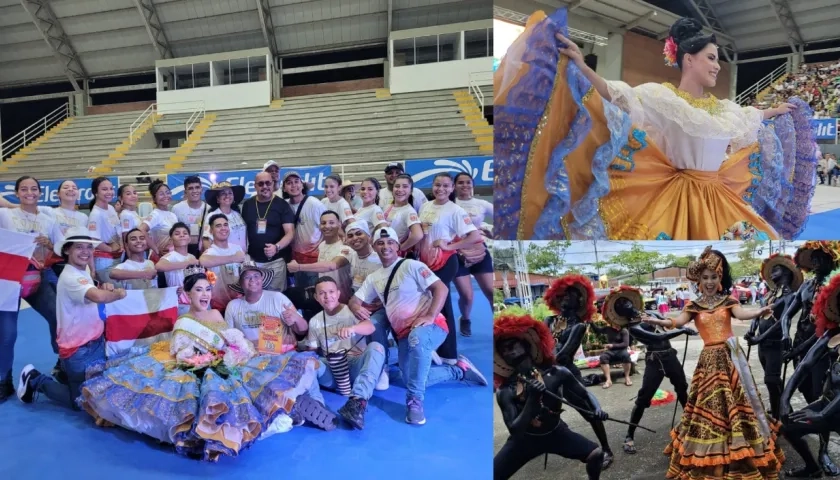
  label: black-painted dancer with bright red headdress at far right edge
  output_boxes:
[781,276,840,478]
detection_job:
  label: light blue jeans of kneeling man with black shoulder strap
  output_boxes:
[397,324,464,401]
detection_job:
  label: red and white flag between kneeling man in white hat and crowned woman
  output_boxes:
[105,287,178,357]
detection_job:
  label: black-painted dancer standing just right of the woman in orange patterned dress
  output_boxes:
[744,253,804,420]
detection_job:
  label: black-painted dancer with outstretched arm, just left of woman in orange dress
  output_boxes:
[602,287,697,454]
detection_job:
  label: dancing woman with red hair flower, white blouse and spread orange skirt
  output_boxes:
[494,9,817,240]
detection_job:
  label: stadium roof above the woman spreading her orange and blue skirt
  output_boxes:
[494,0,840,58]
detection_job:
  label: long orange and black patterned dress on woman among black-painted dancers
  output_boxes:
[665,297,785,480]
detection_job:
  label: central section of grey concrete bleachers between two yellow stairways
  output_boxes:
[173,90,486,180]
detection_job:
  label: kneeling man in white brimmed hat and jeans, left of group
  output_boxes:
[17,227,126,409]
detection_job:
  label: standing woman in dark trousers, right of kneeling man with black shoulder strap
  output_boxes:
[417,173,486,364]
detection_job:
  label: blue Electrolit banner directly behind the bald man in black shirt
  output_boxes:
[166,165,332,202]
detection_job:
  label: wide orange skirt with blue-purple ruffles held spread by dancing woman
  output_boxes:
[494,9,817,240]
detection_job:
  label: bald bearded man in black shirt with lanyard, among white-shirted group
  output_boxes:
[242,172,295,292]
